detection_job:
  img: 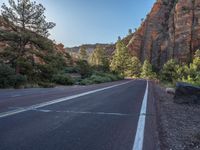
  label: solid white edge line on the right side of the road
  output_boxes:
[132,81,149,150]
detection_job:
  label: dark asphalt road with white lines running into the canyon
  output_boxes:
[0,80,158,150]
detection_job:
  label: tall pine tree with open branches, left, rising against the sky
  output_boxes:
[0,0,55,74]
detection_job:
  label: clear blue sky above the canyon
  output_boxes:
[0,0,155,47]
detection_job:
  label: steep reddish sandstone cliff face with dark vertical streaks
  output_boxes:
[128,0,200,68]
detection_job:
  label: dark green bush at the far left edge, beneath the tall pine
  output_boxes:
[0,64,27,88]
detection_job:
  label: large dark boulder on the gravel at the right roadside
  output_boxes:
[174,82,200,104]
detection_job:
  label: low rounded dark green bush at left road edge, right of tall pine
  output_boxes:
[52,74,75,85]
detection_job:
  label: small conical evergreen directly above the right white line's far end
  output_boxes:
[141,60,156,79]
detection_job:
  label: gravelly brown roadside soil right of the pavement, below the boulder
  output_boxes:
[154,85,200,150]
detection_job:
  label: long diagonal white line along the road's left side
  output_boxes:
[0,81,132,118]
